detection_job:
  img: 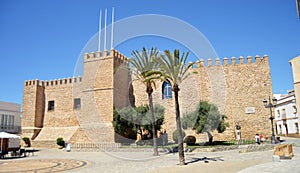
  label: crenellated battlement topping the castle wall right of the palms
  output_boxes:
[196,55,269,68]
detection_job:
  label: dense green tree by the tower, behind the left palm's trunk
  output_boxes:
[112,104,165,145]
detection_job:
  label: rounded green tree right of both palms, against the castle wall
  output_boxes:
[182,101,229,143]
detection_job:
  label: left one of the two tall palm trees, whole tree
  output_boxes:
[129,48,161,156]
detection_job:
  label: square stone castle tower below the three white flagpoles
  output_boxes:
[78,49,130,142]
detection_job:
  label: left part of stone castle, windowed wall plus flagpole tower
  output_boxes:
[22,50,129,146]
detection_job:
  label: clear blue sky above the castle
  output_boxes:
[0,0,300,104]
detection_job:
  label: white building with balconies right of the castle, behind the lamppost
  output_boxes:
[274,90,299,136]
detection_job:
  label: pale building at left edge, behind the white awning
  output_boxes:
[0,101,21,134]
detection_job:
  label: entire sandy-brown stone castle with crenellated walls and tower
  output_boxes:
[22,49,272,147]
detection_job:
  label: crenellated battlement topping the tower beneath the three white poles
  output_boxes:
[84,49,128,62]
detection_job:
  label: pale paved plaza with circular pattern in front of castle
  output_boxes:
[0,138,300,173]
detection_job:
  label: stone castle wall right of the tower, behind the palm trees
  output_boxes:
[134,56,272,140]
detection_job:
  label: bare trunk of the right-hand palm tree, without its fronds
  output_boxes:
[174,88,185,165]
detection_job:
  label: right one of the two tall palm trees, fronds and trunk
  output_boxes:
[157,49,194,165]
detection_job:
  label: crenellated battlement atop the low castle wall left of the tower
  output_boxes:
[24,76,82,87]
